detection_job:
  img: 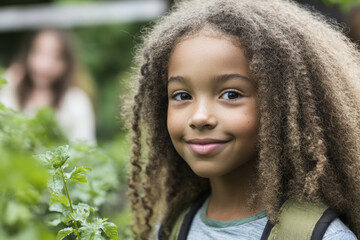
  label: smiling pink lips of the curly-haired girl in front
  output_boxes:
[186,138,229,155]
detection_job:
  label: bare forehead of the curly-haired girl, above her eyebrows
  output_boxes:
[168,35,250,85]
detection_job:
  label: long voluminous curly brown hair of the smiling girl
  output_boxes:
[129,0,360,239]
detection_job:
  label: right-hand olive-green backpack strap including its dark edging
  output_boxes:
[261,199,338,240]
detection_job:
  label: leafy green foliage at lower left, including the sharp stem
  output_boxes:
[0,74,129,240]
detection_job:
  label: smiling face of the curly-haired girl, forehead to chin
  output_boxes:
[167,35,259,178]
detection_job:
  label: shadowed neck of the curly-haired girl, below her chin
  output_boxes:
[207,161,264,221]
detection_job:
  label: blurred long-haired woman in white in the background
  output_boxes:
[0,29,95,143]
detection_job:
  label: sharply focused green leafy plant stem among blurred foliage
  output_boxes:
[37,146,118,240]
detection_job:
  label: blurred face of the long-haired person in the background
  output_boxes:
[27,31,66,87]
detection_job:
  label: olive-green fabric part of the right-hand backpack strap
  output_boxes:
[268,199,336,240]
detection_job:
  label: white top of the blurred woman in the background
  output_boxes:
[0,78,96,143]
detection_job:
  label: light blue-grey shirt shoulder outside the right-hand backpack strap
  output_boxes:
[323,218,357,240]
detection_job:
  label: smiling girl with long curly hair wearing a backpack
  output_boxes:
[129,0,360,240]
